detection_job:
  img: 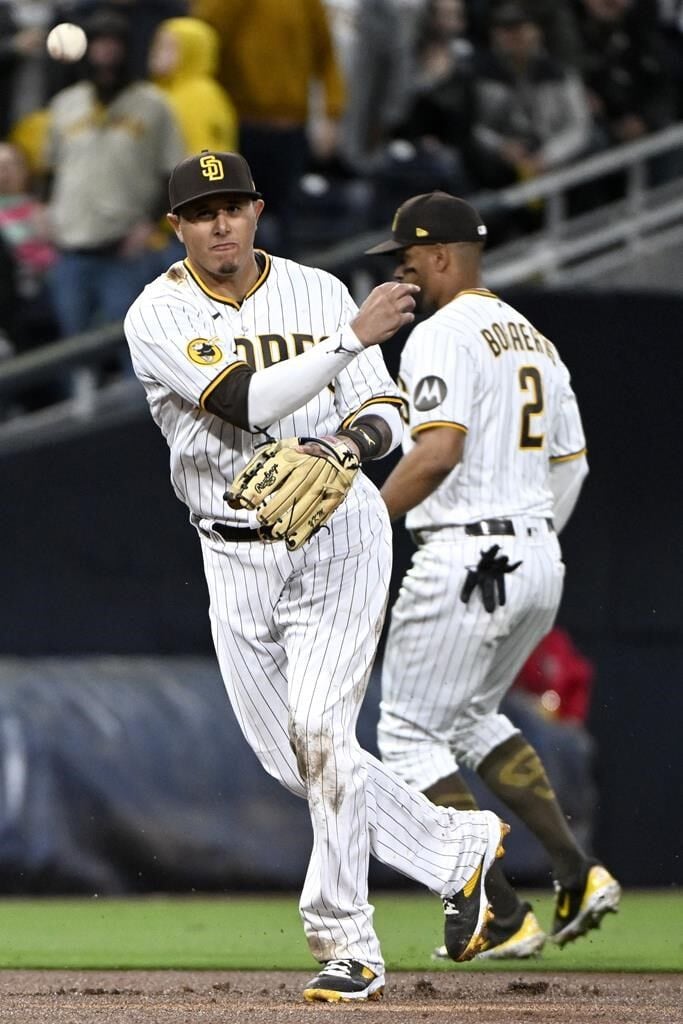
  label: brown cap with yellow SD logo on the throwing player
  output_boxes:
[168,150,261,213]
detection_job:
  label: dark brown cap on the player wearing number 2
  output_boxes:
[366,191,486,254]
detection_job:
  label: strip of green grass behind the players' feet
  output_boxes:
[0,889,683,972]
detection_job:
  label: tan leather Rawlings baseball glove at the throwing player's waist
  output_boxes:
[225,436,360,551]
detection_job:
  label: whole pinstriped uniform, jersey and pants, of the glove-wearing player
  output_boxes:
[125,247,500,975]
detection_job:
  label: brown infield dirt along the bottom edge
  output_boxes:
[0,970,683,1024]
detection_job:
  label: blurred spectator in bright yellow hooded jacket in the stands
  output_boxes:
[148,17,238,154]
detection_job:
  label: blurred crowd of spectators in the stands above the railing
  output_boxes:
[0,0,683,366]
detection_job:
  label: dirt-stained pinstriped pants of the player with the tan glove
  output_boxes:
[201,474,487,971]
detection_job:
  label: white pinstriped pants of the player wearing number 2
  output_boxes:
[378,517,564,791]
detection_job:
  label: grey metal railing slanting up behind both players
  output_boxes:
[0,123,683,454]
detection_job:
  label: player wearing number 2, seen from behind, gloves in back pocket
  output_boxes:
[370,193,620,958]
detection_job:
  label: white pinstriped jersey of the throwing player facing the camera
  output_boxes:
[125,253,400,525]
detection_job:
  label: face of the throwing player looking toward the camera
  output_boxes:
[169,195,263,279]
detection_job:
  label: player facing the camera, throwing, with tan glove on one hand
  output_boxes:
[125,152,507,1001]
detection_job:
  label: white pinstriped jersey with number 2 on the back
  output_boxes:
[399,289,586,529]
